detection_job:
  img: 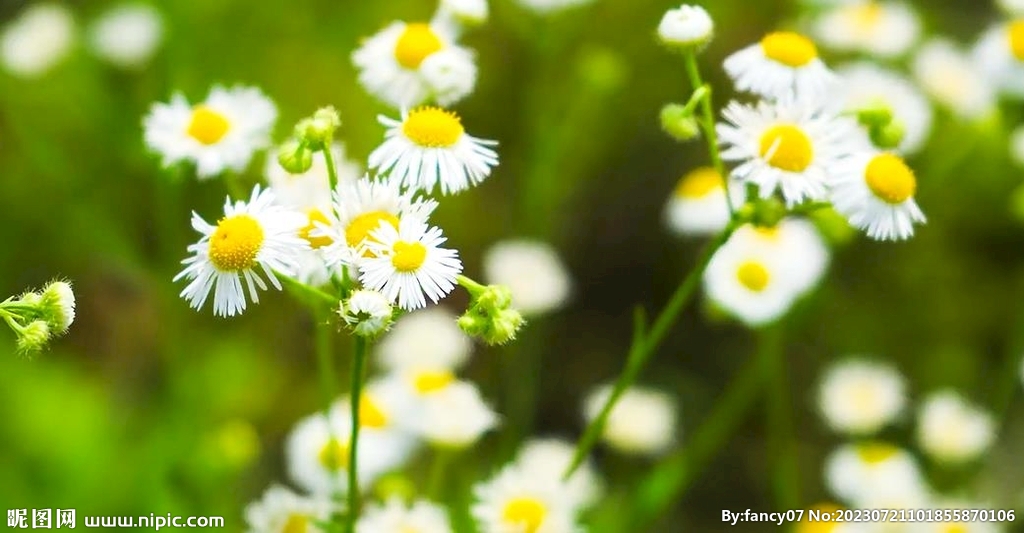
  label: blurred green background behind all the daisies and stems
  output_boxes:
[0,0,1024,532]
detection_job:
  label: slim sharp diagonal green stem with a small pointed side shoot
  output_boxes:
[563,221,739,479]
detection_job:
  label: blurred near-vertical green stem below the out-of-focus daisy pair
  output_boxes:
[758,325,801,510]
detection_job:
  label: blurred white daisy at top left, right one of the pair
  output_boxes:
[90,3,164,69]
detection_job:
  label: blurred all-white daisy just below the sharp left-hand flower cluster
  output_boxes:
[377,307,473,372]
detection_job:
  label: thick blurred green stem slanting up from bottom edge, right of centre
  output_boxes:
[629,345,765,531]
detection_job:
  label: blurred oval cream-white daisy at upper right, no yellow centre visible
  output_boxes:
[911,39,996,121]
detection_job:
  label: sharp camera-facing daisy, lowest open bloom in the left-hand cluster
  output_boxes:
[359,217,462,311]
